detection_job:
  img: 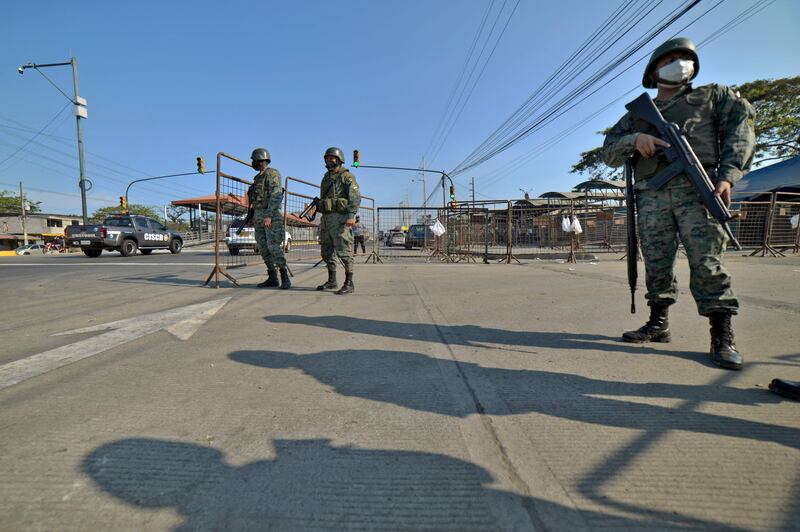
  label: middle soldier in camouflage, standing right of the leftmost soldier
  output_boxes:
[317,148,361,295]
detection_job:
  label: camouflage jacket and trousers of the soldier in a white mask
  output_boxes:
[603,85,755,316]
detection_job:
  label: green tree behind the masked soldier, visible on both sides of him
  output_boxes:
[570,76,800,180]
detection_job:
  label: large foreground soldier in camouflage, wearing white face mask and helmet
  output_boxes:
[603,38,755,369]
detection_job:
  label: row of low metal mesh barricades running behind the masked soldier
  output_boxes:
[377,193,800,263]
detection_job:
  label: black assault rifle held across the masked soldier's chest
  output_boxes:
[625,92,742,253]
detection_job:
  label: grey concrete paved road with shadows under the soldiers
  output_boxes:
[0,253,800,531]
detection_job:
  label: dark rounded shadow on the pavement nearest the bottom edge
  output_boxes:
[82,438,744,531]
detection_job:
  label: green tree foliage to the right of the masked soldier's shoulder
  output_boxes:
[734,76,800,164]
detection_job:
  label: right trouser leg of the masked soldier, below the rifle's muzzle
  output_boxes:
[672,187,739,316]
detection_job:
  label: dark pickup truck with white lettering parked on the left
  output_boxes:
[64,214,183,257]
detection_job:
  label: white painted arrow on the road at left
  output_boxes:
[0,297,231,390]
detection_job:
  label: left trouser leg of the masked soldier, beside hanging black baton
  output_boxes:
[636,188,678,307]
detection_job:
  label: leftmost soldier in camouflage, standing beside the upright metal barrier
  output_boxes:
[247,148,292,290]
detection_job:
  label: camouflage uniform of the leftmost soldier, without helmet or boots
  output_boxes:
[252,168,286,271]
